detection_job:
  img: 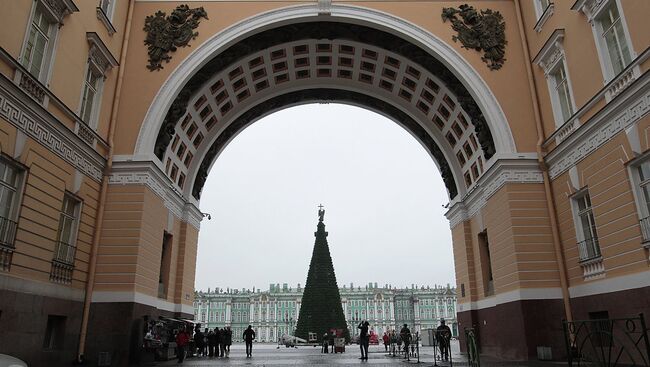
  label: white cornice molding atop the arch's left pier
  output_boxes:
[108,161,203,229]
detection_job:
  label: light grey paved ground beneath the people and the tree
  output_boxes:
[159,342,566,367]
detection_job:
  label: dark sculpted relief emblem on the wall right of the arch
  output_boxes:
[442,4,508,70]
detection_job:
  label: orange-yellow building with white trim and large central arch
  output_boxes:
[0,0,650,366]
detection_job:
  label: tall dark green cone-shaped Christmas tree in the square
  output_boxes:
[296,205,350,343]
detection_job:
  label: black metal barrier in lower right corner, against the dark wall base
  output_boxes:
[562,314,650,367]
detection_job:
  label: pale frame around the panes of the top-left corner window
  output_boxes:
[19,0,59,85]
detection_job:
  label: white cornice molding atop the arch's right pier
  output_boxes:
[445,159,544,228]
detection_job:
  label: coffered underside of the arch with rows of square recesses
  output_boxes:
[153,21,506,204]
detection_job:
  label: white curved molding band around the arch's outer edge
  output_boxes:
[135,3,516,170]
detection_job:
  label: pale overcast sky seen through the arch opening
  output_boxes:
[195,104,455,290]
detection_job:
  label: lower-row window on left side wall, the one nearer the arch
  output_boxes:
[54,194,81,265]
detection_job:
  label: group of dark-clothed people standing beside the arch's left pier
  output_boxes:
[176,325,255,363]
